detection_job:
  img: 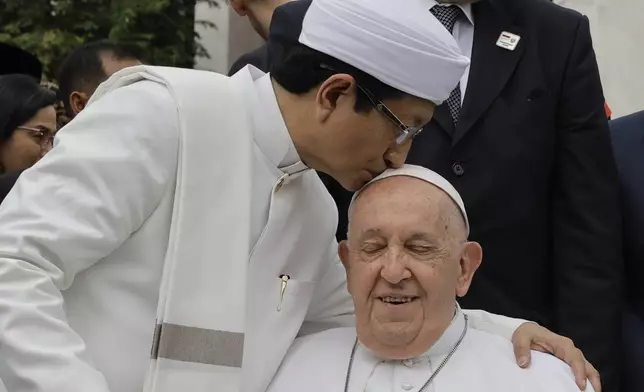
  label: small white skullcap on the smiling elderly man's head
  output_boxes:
[349,165,470,236]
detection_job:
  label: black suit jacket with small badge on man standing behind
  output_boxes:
[231,0,623,392]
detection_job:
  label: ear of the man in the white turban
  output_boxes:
[316,74,357,122]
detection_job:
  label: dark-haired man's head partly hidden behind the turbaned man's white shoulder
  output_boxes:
[58,40,141,119]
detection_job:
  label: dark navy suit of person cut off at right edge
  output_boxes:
[610,111,644,391]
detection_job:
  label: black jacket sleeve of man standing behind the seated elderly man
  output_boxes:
[551,17,623,392]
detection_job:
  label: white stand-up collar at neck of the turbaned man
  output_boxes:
[251,69,308,174]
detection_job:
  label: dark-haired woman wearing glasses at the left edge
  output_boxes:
[0,74,57,201]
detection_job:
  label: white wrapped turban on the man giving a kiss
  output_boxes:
[299,0,469,105]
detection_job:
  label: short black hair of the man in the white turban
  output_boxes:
[271,43,407,113]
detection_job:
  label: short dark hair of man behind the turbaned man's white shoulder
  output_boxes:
[58,40,137,115]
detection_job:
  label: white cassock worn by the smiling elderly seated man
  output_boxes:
[268,309,593,392]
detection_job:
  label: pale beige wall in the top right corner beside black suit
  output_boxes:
[555,0,644,117]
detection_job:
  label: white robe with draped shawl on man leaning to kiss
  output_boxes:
[0,66,521,392]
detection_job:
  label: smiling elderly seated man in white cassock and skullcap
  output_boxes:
[268,165,593,392]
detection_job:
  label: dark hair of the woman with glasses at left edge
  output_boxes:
[0,74,56,142]
